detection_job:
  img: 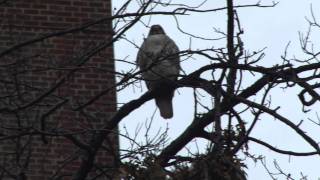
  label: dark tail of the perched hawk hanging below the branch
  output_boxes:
[155,97,173,119]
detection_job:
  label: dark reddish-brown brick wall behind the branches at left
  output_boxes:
[0,0,118,180]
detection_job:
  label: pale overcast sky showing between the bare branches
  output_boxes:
[113,0,320,180]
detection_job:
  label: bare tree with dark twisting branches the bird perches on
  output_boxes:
[0,0,320,180]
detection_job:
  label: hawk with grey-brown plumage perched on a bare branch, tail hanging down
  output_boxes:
[137,25,180,119]
